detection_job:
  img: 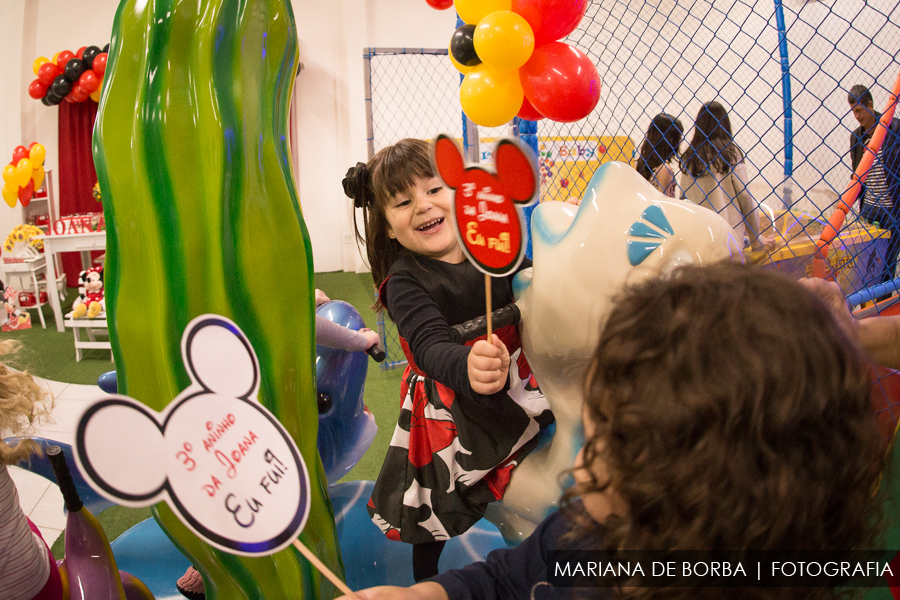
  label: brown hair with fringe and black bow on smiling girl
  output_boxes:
[343,138,434,309]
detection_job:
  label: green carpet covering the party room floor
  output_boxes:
[15,272,403,558]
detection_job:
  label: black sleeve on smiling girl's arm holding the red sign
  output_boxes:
[385,275,509,407]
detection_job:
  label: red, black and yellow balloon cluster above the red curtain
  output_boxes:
[28,44,109,106]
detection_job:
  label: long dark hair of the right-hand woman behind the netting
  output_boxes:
[681,100,744,177]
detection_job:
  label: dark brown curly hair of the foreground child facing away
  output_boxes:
[567,262,886,600]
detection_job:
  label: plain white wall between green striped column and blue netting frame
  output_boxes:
[293,0,456,271]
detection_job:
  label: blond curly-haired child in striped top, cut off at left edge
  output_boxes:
[0,340,63,600]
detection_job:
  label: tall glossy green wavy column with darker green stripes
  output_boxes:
[94,0,343,600]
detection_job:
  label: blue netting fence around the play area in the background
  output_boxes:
[365,0,900,398]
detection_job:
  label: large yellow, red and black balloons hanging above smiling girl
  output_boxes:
[442,0,600,127]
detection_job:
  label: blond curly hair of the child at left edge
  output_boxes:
[0,340,53,465]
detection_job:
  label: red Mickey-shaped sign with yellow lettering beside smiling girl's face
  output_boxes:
[433,134,538,277]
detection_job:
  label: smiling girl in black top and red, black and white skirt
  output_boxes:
[344,139,553,581]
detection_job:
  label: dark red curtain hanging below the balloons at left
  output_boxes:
[58,100,103,287]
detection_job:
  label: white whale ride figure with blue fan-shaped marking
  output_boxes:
[489,162,743,539]
